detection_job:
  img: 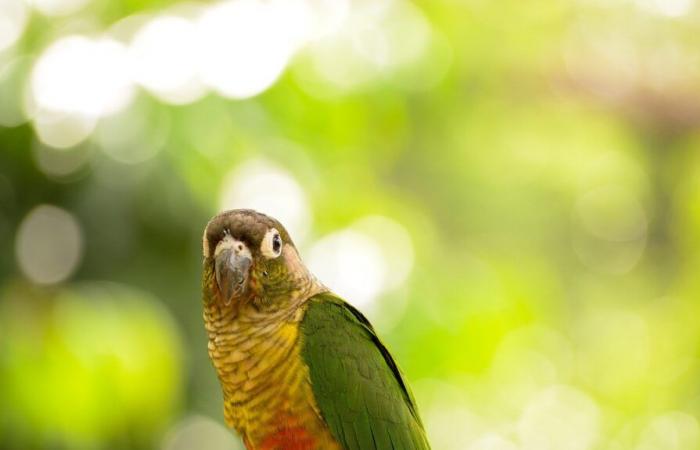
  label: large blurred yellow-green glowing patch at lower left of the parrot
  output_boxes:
[0,282,182,442]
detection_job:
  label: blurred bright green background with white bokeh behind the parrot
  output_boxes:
[0,0,700,450]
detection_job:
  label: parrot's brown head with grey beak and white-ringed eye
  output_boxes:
[202,209,320,306]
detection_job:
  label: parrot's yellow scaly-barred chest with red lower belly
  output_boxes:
[204,303,337,449]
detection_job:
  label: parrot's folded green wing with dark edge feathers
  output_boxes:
[301,294,430,450]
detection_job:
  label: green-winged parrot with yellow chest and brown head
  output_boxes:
[202,209,430,450]
